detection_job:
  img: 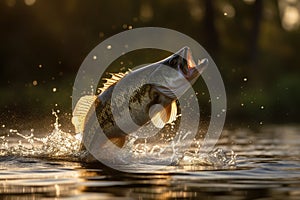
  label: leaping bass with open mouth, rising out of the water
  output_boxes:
[72,47,208,147]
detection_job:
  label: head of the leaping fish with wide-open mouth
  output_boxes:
[154,47,208,99]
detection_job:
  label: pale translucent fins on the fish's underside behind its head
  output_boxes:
[150,101,177,128]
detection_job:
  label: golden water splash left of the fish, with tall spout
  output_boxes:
[0,111,80,160]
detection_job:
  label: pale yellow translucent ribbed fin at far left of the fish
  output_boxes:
[72,95,97,133]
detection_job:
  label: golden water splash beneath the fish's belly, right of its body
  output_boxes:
[120,133,237,169]
